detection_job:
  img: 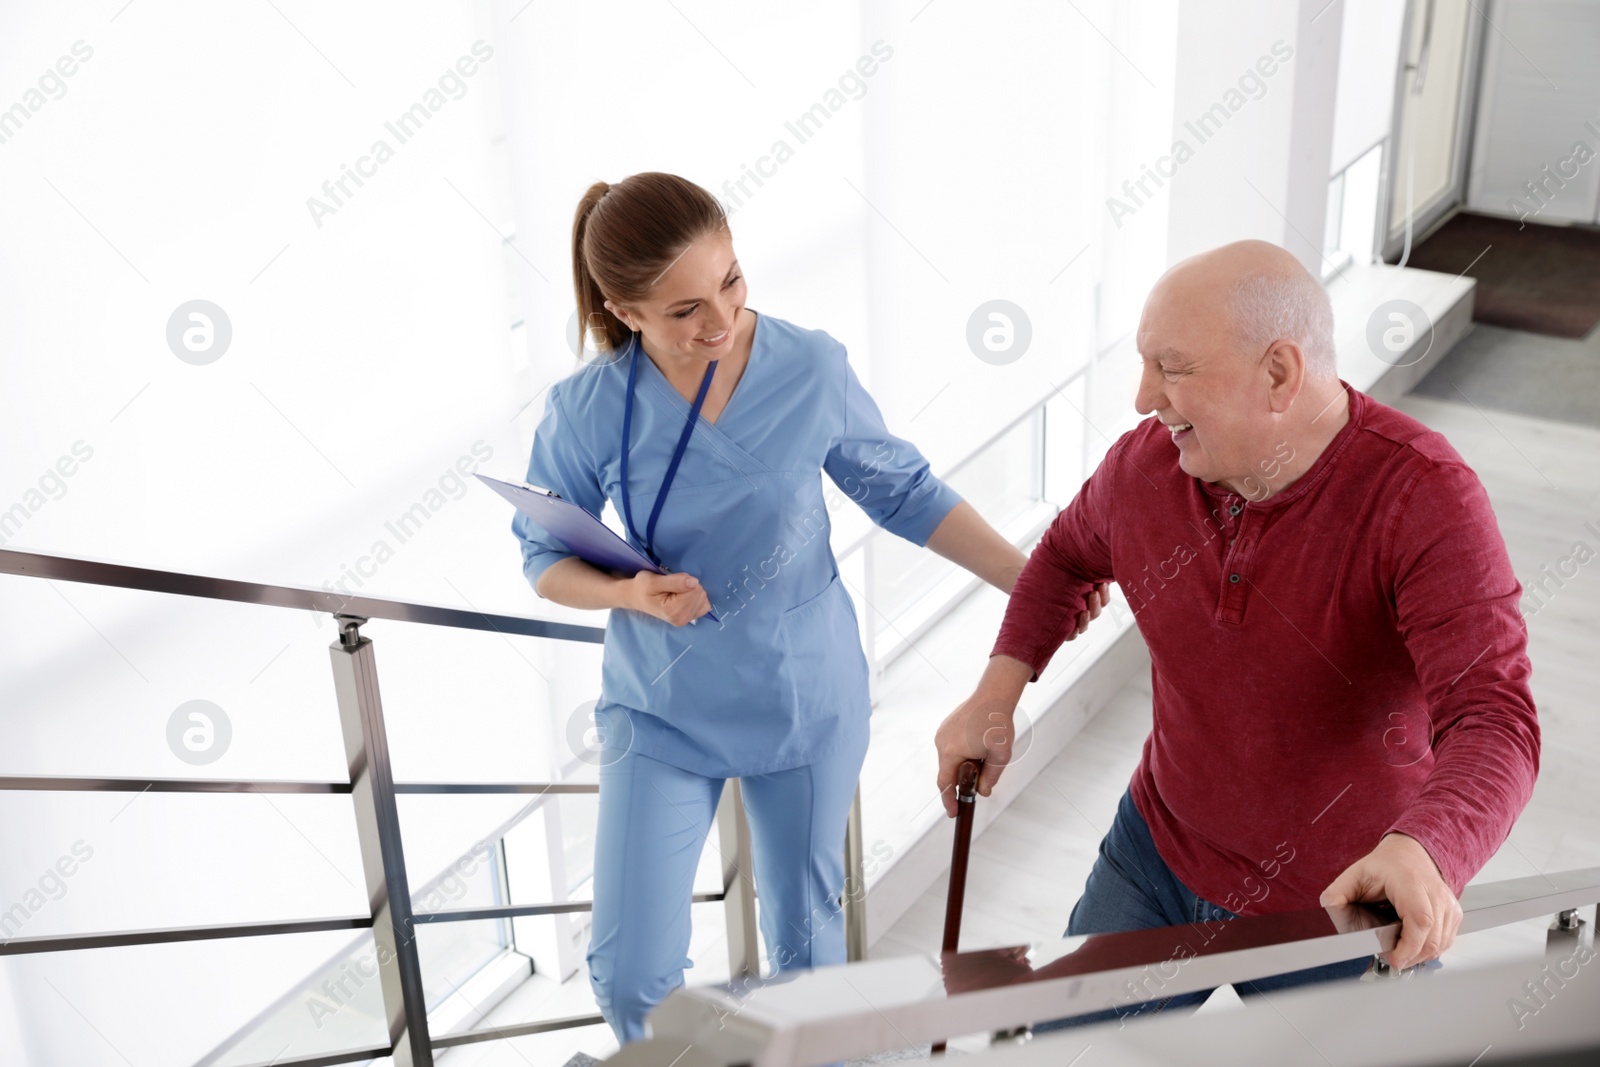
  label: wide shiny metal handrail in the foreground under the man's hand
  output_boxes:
[624,867,1600,1067]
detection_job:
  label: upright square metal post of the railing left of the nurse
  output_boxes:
[328,614,434,1067]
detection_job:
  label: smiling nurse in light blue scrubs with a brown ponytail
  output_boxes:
[512,173,1098,1043]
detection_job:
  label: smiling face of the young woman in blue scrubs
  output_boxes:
[606,229,746,363]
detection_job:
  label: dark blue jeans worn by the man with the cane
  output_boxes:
[1034,792,1371,1032]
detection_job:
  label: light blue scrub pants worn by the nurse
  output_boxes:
[589,717,869,1045]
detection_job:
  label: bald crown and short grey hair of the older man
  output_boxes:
[1150,240,1338,381]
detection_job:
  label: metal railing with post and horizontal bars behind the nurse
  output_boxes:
[0,549,758,1067]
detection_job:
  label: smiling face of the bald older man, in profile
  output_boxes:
[1134,266,1278,493]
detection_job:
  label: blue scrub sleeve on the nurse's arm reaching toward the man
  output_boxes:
[822,358,962,545]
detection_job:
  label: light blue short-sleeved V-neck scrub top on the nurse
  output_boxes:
[512,315,962,777]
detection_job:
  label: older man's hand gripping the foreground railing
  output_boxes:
[1320,833,1461,971]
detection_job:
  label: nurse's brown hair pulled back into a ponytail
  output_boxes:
[573,171,728,352]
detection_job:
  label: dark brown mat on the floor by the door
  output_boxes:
[1406,211,1600,338]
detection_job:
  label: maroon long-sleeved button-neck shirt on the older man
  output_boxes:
[994,386,1539,913]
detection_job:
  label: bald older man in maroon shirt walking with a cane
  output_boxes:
[936,242,1539,1029]
